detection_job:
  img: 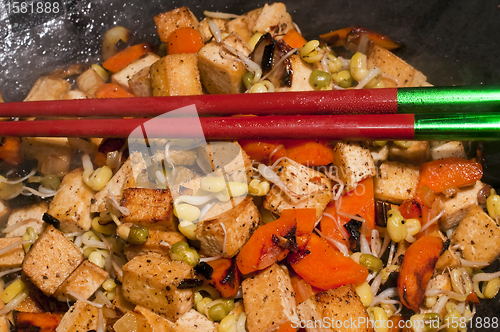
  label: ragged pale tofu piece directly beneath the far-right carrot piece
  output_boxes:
[439,181,485,230]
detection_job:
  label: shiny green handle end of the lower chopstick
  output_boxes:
[415,113,500,141]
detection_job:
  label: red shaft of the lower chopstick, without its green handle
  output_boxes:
[0,114,414,140]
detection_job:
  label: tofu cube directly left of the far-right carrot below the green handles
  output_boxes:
[374,161,420,204]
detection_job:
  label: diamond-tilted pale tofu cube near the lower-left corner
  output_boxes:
[23,225,84,296]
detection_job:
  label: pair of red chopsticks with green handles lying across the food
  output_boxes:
[0,87,500,140]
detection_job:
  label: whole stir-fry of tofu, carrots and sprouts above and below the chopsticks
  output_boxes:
[0,3,500,332]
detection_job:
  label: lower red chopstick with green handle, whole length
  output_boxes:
[0,113,500,140]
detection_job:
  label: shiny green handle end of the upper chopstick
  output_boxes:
[397,86,500,114]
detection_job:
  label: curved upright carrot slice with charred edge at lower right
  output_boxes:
[398,235,443,312]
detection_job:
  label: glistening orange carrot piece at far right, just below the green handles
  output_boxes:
[418,157,483,193]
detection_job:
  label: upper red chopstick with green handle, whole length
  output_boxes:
[0,86,500,117]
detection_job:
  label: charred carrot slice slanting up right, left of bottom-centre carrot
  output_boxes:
[236,209,299,274]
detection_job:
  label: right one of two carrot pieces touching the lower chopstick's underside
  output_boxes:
[285,140,333,166]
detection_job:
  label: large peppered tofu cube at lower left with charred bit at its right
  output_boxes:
[122,252,194,322]
